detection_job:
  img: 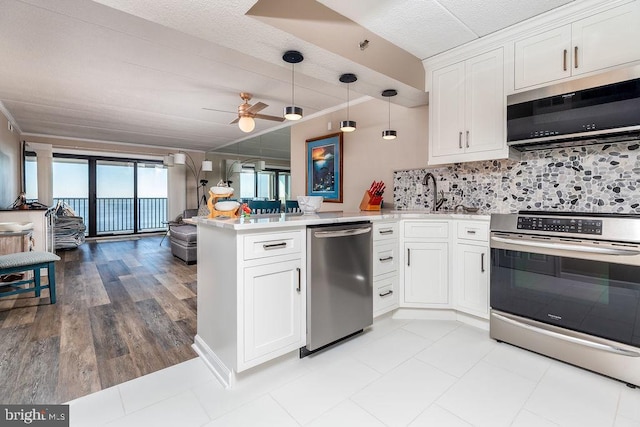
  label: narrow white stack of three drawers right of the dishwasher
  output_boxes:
[373,221,400,317]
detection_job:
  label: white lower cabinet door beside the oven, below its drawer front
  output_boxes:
[453,243,489,318]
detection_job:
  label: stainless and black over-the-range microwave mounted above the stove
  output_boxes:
[507,65,640,151]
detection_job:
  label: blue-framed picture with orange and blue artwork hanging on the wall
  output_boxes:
[307,132,342,203]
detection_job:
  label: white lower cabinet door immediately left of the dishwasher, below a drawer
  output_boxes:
[245,260,305,370]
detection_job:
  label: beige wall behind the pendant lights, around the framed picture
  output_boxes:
[291,99,429,212]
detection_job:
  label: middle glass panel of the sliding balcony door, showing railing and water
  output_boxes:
[96,160,137,235]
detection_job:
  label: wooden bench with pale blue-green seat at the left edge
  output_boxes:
[0,252,60,304]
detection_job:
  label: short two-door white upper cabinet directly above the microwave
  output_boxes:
[514,1,640,90]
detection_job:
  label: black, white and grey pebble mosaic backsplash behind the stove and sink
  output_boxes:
[393,141,640,213]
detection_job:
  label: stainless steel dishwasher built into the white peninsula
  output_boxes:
[300,222,373,357]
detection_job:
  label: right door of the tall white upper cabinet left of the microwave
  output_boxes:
[463,49,506,153]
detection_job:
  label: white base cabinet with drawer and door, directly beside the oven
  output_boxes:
[452,221,489,319]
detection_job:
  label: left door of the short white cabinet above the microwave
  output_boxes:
[514,25,573,89]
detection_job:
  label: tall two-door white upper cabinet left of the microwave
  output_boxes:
[429,48,509,165]
